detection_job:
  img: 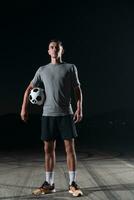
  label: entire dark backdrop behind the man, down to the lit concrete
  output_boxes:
[0,0,134,147]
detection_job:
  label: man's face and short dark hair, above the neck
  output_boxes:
[48,42,63,58]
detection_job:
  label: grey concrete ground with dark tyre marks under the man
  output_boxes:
[0,147,134,200]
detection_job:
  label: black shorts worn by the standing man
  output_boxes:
[41,115,77,141]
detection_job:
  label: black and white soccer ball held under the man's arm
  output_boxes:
[29,87,45,106]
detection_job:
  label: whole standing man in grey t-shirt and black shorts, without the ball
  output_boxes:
[21,40,83,196]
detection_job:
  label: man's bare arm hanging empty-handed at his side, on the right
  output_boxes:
[74,86,83,123]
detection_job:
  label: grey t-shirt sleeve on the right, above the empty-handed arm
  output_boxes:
[71,65,80,88]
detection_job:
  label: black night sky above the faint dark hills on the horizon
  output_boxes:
[0,0,134,116]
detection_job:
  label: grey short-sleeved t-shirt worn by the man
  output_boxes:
[31,63,80,116]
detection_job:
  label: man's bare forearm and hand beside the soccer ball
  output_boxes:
[20,83,33,122]
